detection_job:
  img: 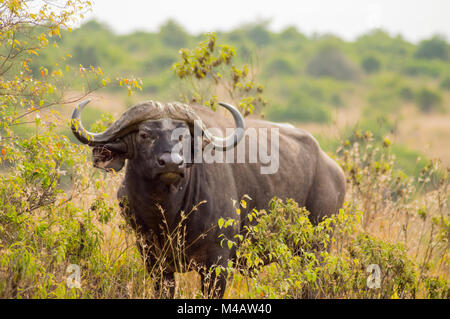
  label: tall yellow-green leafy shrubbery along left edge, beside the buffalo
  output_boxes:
[0,1,145,298]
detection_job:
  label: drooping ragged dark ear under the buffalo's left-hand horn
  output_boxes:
[92,141,127,172]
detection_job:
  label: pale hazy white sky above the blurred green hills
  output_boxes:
[85,0,450,41]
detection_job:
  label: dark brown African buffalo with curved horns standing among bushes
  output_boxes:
[72,101,345,297]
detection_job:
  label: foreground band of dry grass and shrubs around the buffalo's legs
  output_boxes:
[0,127,449,298]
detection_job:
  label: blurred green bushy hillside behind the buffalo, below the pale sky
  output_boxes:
[22,20,450,178]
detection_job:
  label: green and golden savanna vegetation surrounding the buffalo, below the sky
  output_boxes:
[0,0,450,298]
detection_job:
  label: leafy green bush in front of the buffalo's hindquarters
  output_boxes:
[229,198,417,298]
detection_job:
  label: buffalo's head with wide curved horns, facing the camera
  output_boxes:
[72,100,244,185]
